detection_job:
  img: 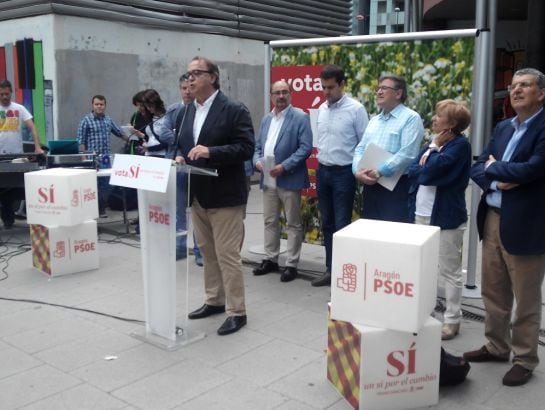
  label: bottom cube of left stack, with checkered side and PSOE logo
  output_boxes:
[30,220,98,276]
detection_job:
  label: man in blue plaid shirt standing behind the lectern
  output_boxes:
[78,95,128,218]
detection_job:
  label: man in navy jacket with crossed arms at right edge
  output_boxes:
[464,68,545,386]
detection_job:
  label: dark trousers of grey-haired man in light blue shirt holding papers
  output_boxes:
[361,175,409,223]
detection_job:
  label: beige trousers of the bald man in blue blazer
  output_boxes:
[263,187,303,268]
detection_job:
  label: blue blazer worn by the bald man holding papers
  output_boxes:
[254,107,312,190]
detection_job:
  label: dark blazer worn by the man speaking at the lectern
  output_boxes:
[176,91,255,209]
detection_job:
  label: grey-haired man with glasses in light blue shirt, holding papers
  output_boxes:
[352,74,424,223]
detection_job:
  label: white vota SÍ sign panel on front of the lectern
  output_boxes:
[110,154,172,193]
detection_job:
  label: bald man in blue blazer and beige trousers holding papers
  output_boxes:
[254,80,312,282]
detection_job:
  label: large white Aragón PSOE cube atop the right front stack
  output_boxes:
[331,219,440,332]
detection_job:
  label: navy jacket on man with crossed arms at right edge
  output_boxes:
[471,110,545,255]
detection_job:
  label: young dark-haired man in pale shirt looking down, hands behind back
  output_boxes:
[312,65,369,286]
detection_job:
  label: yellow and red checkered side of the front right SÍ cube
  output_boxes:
[327,319,361,409]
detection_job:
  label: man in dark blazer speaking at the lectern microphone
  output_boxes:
[176,57,254,335]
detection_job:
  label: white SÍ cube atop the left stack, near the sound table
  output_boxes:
[25,168,98,226]
